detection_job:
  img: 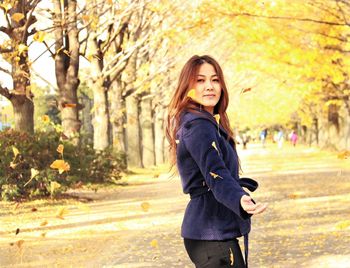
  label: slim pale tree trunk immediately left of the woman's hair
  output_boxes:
[154,105,165,165]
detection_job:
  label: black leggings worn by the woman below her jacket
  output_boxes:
[184,238,245,268]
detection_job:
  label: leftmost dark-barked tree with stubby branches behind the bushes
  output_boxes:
[0,0,40,133]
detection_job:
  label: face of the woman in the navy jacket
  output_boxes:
[193,62,221,114]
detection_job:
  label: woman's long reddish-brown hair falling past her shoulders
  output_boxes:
[166,55,234,167]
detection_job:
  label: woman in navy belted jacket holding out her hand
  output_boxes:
[167,55,266,268]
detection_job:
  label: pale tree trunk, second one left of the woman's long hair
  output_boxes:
[140,97,156,167]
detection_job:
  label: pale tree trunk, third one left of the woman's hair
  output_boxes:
[126,96,143,167]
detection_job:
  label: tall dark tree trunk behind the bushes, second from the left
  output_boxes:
[53,0,81,144]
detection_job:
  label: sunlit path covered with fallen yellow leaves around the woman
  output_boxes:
[0,144,350,268]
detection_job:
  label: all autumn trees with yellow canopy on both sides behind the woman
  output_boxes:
[0,0,350,170]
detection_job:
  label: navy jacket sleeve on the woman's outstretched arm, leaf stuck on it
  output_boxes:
[182,119,251,219]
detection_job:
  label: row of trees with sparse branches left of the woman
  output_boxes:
[0,0,204,166]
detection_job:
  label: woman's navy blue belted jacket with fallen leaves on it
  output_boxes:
[177,110,251,240]
